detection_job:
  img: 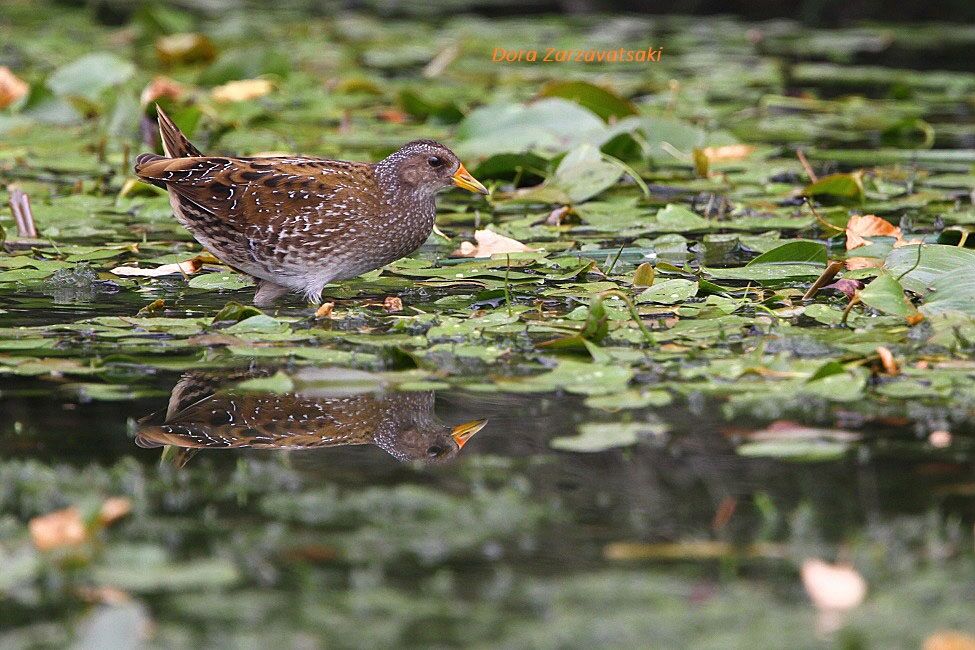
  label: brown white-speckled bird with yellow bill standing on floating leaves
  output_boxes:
[135,108,487,306]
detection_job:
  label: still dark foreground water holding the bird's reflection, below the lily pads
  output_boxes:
[0,370,975,647]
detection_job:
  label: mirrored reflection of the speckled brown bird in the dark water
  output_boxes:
[135,371,487,467]
